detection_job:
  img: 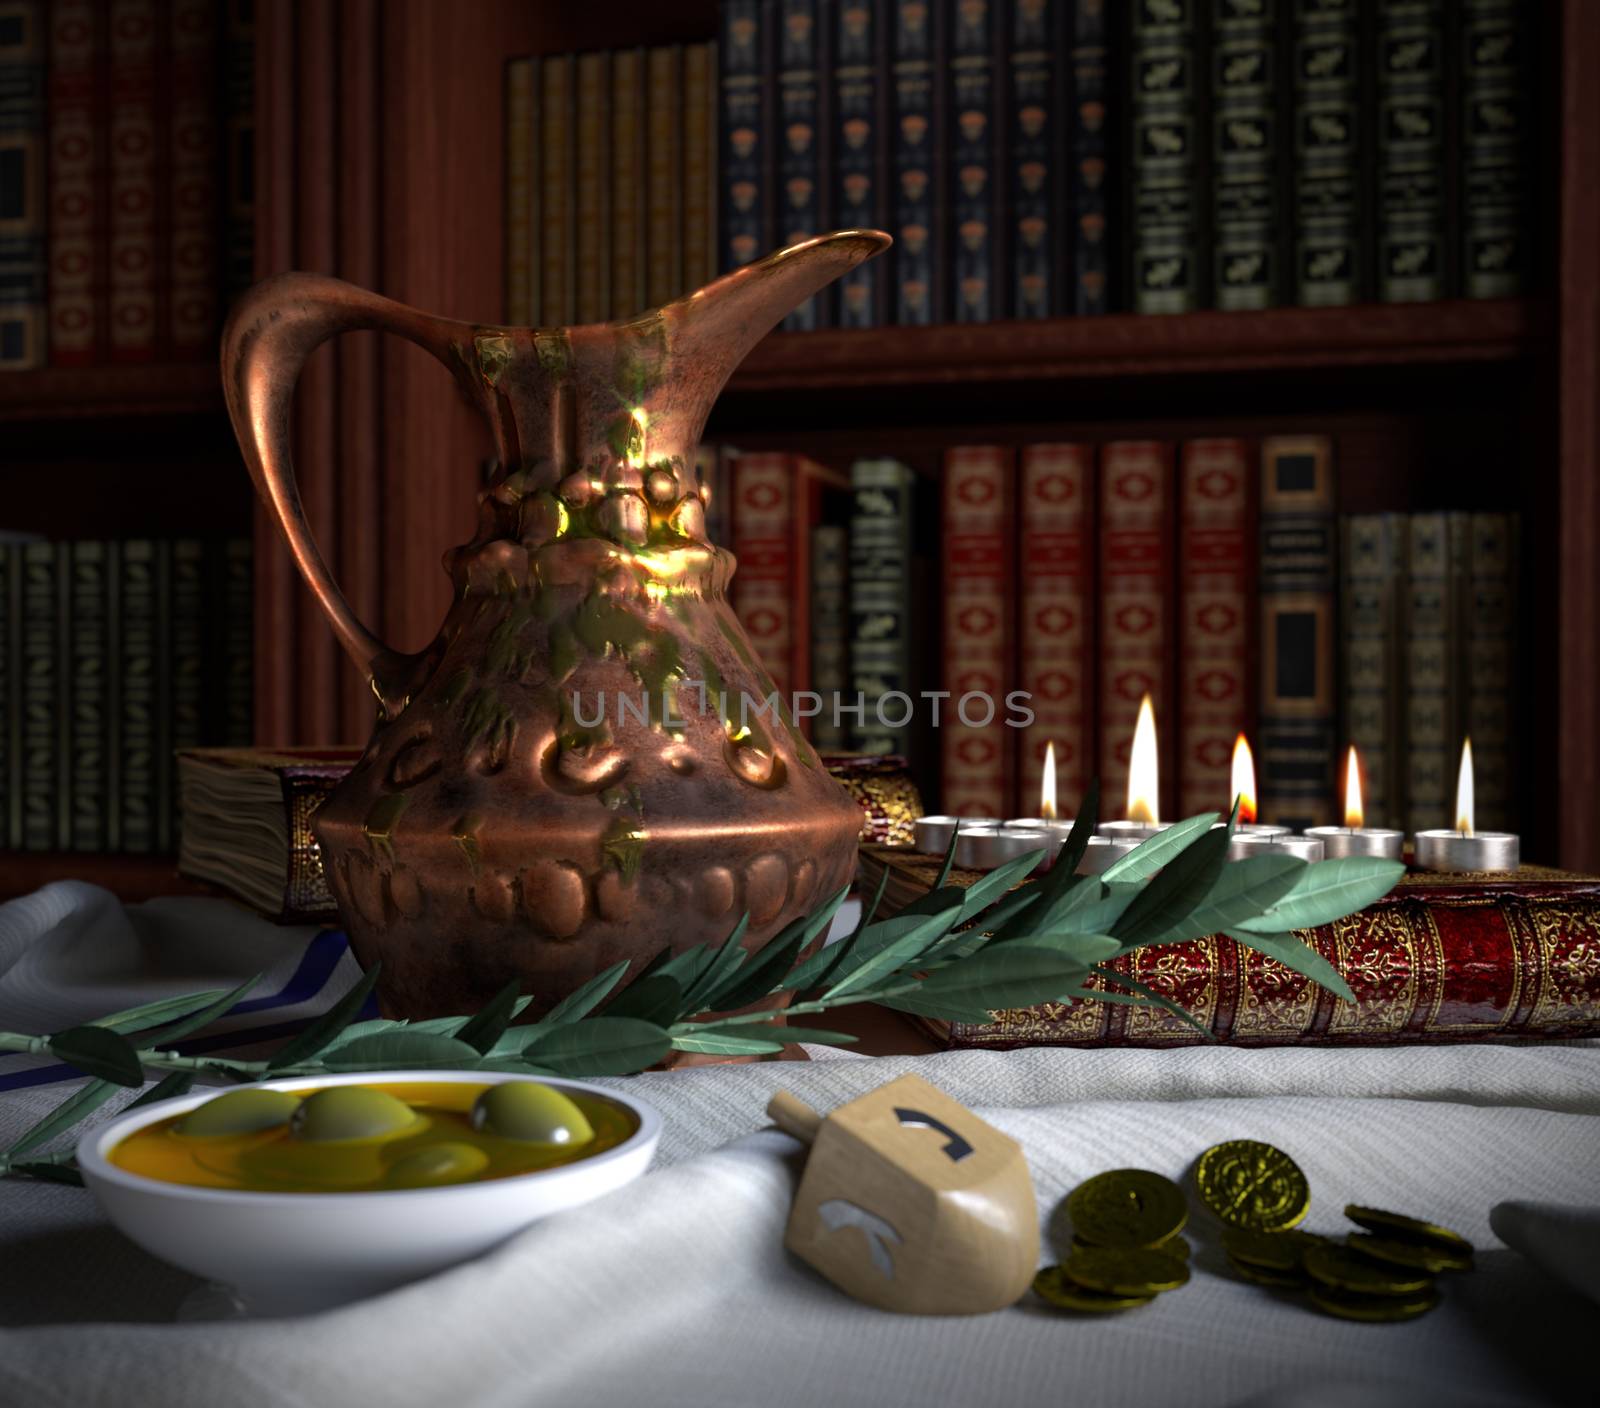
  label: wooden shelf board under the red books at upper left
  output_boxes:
[0,358,222,421]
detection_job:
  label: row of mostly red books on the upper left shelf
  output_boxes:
[0,0,254,368]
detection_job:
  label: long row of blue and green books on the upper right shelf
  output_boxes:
[718,0,1534,326]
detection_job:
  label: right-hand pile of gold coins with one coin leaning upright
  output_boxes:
[1195,1139,1472,1322]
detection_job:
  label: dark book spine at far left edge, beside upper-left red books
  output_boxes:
[0,0,50,371]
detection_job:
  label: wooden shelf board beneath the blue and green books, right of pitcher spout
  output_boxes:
[728,299,1552,395]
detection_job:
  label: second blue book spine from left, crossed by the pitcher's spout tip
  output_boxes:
[776,0,829,333]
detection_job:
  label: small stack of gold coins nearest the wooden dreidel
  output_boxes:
[1034,1168,1189,1314]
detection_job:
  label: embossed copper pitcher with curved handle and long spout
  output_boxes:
[222,230,890,1018]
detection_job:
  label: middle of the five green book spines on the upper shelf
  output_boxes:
[1293,0,1365,307]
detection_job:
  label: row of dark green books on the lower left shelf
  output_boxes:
[0,539,253,853]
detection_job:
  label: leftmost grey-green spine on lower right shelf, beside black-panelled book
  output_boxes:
[1338,514,1406,827]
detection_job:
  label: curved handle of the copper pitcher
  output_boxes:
[222,274,493,717]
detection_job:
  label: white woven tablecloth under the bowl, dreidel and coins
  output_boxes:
[0,886,1600,1408]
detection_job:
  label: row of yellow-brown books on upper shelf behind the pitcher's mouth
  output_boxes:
[506,43,717,326]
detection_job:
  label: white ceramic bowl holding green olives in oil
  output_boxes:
[78,1070,661,1315]
